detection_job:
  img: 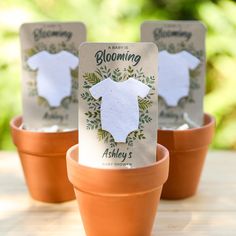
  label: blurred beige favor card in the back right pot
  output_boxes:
[141,21,205,129]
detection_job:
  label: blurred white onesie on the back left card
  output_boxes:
[27,51,79,107]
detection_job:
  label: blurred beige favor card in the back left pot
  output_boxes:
[20,22,86,130]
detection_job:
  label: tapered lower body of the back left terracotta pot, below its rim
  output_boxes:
[19,152,75,203]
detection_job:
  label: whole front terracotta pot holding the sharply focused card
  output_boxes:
[67,144,169,236]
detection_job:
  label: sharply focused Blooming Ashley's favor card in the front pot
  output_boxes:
[79,43,158,168]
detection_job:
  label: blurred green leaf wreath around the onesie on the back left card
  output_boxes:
[23,42,78,110]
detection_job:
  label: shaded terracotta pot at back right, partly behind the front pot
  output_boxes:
[158,114,215,199]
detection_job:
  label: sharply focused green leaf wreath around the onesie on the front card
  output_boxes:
[81,66,155,148]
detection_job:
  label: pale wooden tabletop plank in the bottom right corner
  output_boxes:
[153,211,236,236]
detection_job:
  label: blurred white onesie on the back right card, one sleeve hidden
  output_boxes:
[158,50,200,106]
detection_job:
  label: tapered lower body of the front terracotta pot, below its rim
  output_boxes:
[75,188,161,236]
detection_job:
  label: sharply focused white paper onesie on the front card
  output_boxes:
[89,78,150,142]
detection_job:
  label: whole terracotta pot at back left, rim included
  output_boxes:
[10,116,78,203]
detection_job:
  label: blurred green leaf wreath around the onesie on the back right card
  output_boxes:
[158,42,204,109]
